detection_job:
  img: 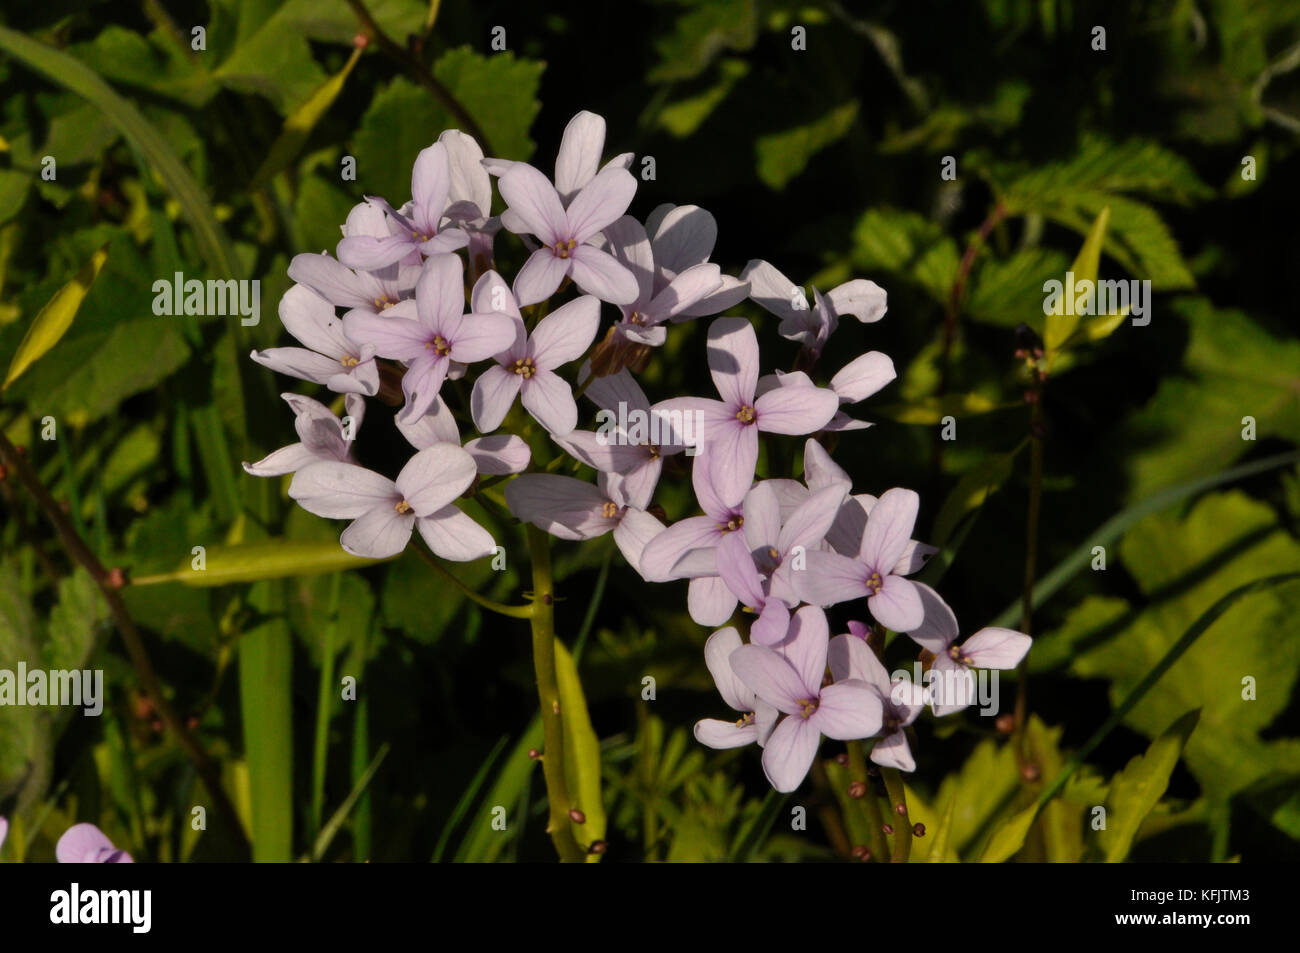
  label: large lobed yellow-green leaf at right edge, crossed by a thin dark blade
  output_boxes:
[1071,491,1300,800]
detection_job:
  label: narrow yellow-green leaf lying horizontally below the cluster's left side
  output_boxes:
[131,540,395,586]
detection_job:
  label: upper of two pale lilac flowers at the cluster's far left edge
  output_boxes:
[252,285,380,397]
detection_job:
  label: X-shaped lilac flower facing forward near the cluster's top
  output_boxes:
[498,163,637,304]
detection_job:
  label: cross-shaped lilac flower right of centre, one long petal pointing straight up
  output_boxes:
[663,317,840,503]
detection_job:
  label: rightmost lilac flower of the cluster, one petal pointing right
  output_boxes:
[907,582,1034,715]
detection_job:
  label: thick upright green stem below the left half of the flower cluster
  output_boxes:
[525,525,586,863]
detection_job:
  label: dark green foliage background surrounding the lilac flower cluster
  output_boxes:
[0,0,1300,861]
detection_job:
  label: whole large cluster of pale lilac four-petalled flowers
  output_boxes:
[246,112,1030,792]
